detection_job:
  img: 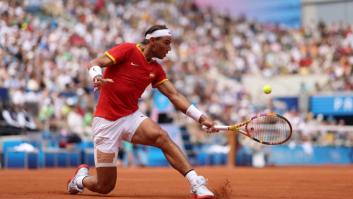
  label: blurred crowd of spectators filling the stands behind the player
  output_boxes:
[0,0,353,152]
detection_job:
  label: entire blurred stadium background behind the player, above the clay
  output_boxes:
[0,0,353,168]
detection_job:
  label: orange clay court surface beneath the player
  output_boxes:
[0,166,353,199]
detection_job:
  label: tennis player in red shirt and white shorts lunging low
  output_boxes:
[67,25,215,198]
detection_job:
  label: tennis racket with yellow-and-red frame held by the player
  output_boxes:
[209,113,292,145]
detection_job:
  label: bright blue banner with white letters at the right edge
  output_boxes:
[310,95,353,116]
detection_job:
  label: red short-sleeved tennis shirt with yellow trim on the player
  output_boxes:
[95,43,167,121]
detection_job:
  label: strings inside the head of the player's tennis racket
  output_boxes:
[247,115,291,144]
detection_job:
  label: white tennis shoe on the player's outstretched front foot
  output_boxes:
[191,176,215,199]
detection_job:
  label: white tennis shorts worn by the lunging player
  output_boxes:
[92,110,148,167]
